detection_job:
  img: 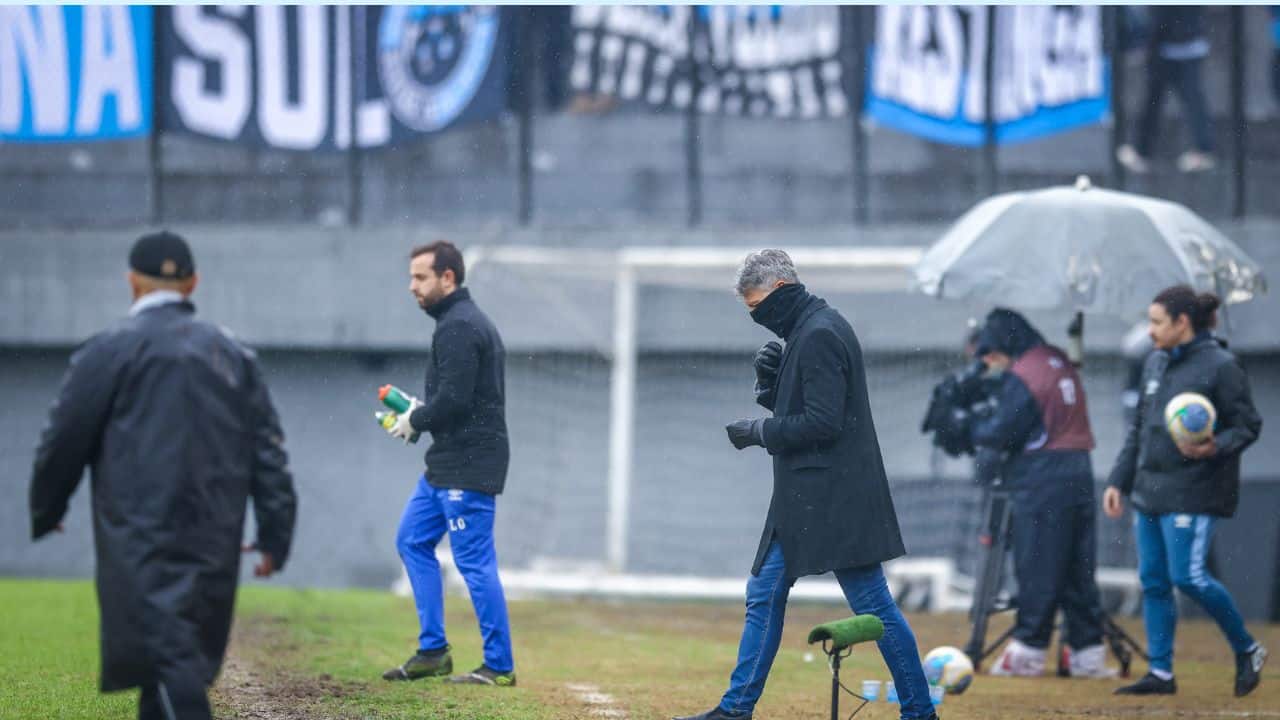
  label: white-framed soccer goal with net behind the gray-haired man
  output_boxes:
[394,246,1136,610]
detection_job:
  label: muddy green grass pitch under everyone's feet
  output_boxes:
[0,580,1280,720]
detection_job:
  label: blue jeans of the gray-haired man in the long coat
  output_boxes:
[719,542,933,719]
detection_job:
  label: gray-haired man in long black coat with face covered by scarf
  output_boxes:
[684,250,936,720]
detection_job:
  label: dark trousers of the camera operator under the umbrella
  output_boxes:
[1011,493,1102,650]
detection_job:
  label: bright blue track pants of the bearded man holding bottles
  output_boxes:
[396,475,515,673]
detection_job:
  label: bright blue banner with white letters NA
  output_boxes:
[0,5,151,142]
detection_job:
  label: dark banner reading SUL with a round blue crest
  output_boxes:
[157,5,507,150]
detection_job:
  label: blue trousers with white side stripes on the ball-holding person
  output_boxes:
[1134,512,1253,673]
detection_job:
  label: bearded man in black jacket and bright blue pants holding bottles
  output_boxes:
[383,241,516,685]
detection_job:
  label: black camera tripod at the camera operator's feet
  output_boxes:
[964,479,1149,678]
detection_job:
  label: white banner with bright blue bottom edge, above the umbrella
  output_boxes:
[864,5,1110,146]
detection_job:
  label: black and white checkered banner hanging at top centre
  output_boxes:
[570,5,849,118]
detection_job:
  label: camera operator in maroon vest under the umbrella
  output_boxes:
[969,307,1115,678]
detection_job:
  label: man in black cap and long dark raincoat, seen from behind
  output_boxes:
[31,232,297,720]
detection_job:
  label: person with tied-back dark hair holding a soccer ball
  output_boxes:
[1102,286,1267,697]
